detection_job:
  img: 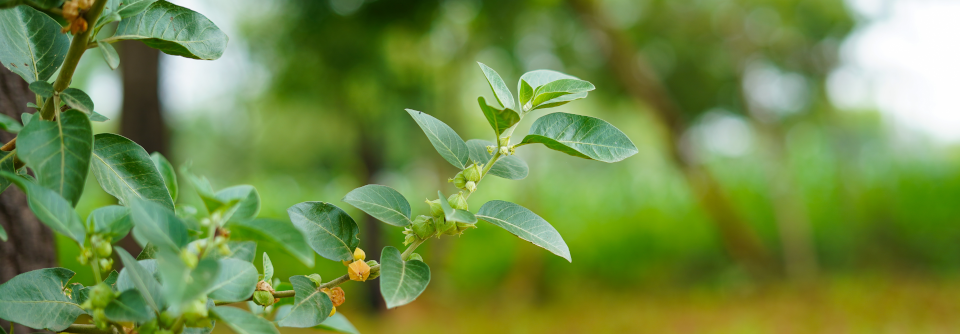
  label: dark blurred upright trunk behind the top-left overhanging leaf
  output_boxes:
[114,41,170,256]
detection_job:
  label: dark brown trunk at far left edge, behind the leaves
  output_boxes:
[0,67,57,334]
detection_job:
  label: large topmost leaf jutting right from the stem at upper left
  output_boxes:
[101,1,227,60]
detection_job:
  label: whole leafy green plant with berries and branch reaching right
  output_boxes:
[0,0,637,334]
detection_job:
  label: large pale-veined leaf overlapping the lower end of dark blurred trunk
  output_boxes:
[93,133,173,210]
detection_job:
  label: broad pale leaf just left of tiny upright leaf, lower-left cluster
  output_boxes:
[207,253,256,303]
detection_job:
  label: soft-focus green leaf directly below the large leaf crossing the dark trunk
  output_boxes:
[130,199,189,253]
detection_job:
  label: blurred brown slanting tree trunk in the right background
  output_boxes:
[571,0,774,275]
